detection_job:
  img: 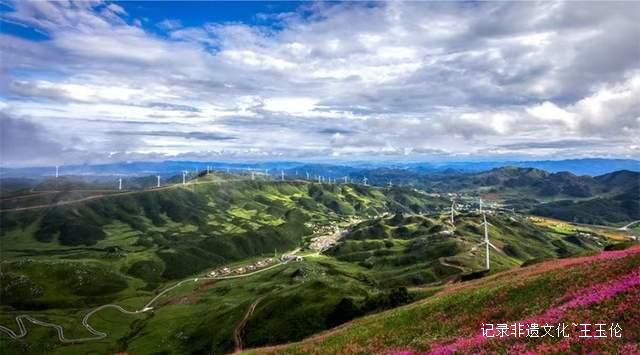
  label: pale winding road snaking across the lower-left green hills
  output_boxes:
[0,261,287,343]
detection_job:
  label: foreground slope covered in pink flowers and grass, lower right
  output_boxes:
[250,246,640,354]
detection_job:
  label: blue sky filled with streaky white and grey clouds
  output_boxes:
[0,0,640,166]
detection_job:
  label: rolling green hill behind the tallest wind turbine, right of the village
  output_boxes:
[329,213,607,286]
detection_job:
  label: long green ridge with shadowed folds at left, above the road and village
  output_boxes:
[0,177,444,298]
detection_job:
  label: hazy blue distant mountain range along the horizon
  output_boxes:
[0,158,640,183]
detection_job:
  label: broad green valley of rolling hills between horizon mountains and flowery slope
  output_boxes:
[0,172,634,354]
